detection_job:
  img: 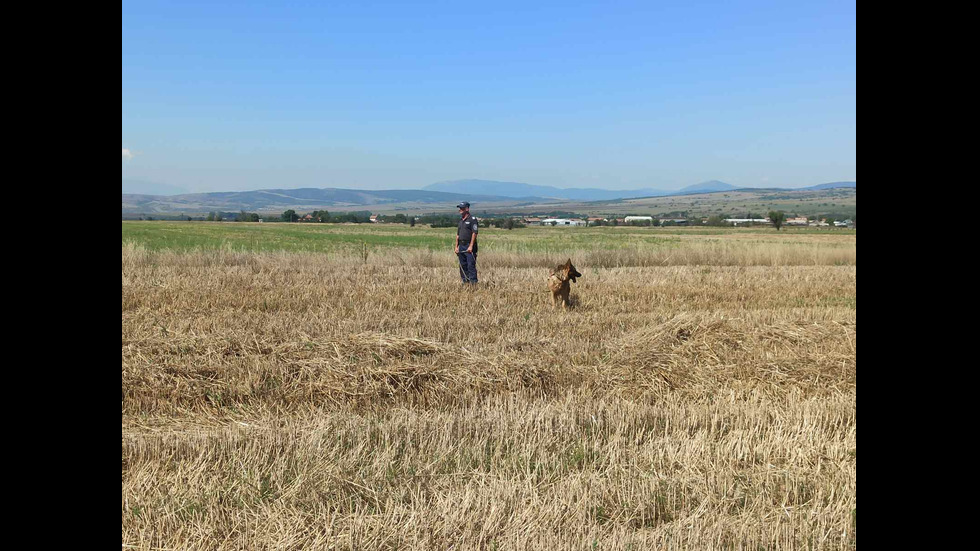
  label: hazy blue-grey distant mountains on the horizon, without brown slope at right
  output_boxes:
[122,180,857,214]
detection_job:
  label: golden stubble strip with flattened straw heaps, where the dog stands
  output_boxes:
[122,250,856,412]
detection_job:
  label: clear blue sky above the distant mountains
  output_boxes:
[122,0,857,191]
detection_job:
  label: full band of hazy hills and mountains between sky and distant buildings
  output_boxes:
[122,180,857,215]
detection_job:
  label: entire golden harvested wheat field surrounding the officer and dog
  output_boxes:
[122,224,857,550]
